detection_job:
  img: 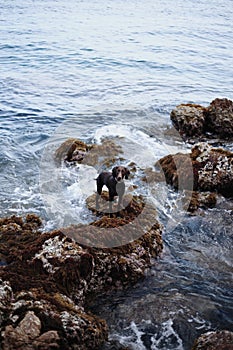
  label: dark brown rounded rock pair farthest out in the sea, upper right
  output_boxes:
[170,98,233,140]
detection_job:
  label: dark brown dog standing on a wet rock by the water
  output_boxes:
[96,166,130,215]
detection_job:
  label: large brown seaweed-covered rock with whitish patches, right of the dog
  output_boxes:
[157,143,233,207]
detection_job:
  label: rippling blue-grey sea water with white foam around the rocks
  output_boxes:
[0,0,233,350]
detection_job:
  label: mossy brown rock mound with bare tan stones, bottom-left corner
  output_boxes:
[1,289,107,350]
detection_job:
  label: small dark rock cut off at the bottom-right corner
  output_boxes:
[192,330,233,350]
